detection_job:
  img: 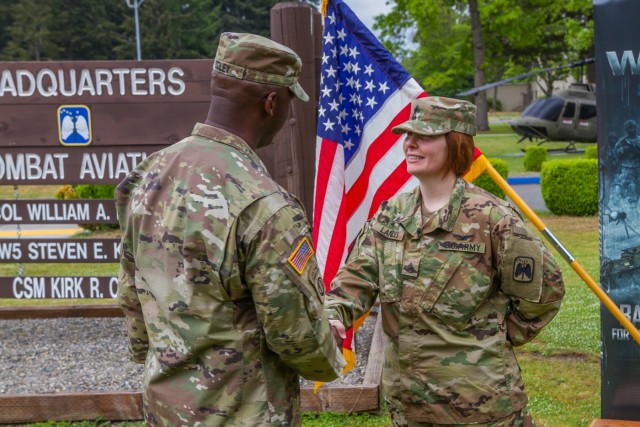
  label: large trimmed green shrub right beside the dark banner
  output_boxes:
[540,159,598,216]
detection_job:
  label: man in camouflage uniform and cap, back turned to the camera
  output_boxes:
[116,33,344,426]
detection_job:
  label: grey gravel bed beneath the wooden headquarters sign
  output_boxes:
[0,310,376,394]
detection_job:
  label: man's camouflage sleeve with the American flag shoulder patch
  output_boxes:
[245,204,345,381]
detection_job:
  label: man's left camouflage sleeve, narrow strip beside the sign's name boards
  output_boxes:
[116,184,149,363]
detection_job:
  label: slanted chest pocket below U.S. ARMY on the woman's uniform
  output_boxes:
[419,253,491,330]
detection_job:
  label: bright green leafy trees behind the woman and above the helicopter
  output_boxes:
[375,0,593,129]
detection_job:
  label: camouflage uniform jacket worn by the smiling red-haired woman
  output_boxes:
[326,178,564,425]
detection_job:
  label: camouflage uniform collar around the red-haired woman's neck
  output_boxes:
[398,177,467,237]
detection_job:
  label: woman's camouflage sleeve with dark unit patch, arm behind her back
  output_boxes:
[493,216,564,346]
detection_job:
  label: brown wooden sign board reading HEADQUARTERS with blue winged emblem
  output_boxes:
[0,60,213,148]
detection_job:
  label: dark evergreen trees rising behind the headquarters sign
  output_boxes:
[0,0,319,61]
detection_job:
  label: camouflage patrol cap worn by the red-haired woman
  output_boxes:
[392,96,476,136]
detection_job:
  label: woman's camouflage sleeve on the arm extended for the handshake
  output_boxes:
[326,222,380,329]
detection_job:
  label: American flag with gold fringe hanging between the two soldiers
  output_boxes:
[313,0,427,372]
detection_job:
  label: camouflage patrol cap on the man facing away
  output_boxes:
[213,33,309,102]
